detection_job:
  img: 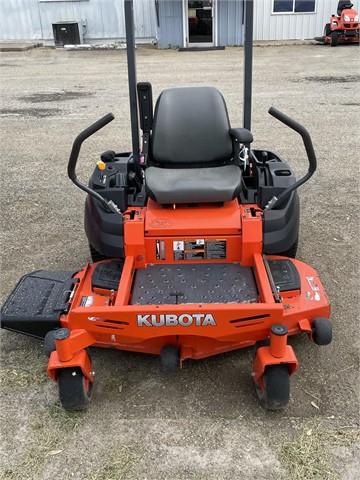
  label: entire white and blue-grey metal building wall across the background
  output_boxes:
[0,0,359,44]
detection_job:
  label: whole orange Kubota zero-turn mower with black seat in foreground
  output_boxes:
[2,0,331,410]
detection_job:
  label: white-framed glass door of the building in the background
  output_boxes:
[186,0,214,46]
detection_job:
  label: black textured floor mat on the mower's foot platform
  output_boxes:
[131,263,258,305]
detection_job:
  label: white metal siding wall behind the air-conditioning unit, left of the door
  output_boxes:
[0,0,156,43]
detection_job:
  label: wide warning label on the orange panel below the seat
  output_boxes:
[173,238,226,260]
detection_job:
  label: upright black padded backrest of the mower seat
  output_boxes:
[151,87,233,167]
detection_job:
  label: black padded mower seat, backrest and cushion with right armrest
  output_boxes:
[145,87,252,204]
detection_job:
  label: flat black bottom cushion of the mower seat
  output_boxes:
[145,165,241,204]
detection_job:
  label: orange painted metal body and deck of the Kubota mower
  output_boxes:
[48,200,329,378]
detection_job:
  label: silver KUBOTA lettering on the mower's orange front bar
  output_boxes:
[137,313,216,327]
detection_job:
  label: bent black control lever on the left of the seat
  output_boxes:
[68,113,121,214]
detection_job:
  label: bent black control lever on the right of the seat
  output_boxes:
[265,107,317,210]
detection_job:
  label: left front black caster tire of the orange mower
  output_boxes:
[58,367,92,412]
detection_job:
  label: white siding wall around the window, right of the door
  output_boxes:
[254,0,359,40]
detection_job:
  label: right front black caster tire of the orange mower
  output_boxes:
[256,364,290,410]
